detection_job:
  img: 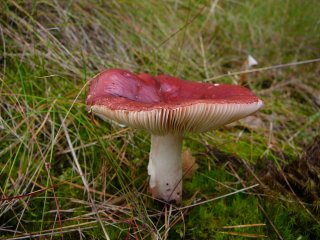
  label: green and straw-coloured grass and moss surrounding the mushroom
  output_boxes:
[0,0,320,239]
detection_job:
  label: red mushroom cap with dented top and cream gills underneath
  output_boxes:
[87,69,263,134]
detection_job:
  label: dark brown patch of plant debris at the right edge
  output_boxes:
[207,135,320,212]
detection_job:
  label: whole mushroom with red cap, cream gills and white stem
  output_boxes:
[87,69,263,204]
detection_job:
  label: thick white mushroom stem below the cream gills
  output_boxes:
[148,134,183,203]
